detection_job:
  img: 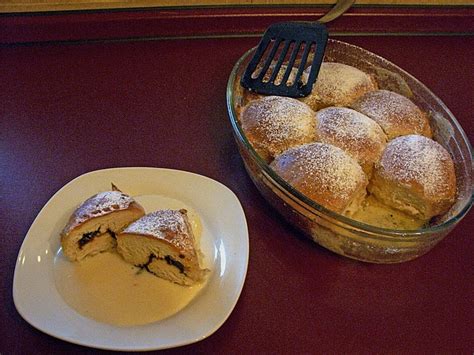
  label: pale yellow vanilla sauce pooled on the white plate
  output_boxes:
[54,195,205,326]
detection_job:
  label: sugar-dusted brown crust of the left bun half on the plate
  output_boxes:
[61,191,144,236]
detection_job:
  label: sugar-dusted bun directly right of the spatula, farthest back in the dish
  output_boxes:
[300,62,377,111]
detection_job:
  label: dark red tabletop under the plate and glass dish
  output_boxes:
[0,29,474,354]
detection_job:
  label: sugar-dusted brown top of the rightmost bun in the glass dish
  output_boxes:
[376,135,456,202]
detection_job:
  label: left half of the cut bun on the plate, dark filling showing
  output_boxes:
[61,185,145,261]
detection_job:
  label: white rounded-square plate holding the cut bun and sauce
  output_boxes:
[13,168,249,351]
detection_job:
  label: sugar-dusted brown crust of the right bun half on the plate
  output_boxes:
[122,209,196,257]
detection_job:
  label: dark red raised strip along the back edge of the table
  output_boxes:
[0,6,474,44]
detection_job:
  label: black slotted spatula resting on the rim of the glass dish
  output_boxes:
[240,0,354,97]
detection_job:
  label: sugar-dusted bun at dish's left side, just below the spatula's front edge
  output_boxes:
[240,96,315,161]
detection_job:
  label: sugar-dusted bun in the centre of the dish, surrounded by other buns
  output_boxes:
[316,107,387,178]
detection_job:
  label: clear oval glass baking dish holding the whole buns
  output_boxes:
[227,40,472,263]
